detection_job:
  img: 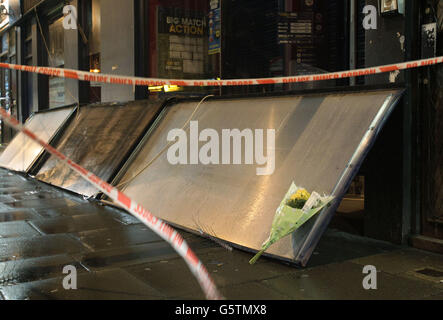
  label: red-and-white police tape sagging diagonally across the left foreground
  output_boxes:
[0,107,223,300]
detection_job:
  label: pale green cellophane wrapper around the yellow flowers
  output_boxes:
[249,183,334,264]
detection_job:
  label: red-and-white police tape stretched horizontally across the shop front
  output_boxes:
[0,56,443,87]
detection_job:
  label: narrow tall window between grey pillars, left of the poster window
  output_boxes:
[48,17,65,108]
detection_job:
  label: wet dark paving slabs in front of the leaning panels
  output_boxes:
[0,169,443,300]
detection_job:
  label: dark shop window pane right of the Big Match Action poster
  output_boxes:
[222,0,349,92]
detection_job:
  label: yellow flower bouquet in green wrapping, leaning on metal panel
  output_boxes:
[249,183,334,264]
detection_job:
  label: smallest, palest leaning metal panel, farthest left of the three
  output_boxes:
[0,107,75,172]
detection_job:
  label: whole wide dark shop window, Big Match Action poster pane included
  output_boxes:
[149,0,349,93]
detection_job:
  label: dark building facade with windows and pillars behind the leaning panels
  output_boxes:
[0,0,443,250]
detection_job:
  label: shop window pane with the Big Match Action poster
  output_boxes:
[149,0,220,93]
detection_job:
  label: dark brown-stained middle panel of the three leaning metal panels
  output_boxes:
[36,100,164,197]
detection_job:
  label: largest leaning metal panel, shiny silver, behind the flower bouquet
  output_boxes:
[116,90,400,262]
